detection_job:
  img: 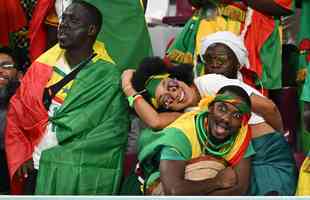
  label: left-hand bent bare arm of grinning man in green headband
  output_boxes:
[159,160,237,195]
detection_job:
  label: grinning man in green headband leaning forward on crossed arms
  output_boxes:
[139,86,254,195]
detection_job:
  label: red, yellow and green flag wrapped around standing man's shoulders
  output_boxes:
[6,42,129,194]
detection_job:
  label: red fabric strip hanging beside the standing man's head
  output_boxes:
[29,0,55,62]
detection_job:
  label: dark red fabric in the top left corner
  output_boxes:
[0,0,27,46]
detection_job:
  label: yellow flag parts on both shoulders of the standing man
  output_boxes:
[36,41,114,67]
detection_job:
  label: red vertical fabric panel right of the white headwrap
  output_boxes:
[245,11,275,79]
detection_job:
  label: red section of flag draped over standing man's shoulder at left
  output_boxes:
[5,62,52,194]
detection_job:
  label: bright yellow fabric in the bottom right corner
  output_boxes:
[296,156,310,196]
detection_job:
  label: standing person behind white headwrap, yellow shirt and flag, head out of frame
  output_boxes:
[167,0,293,89]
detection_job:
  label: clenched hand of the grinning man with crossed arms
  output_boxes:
[215,167,238,189]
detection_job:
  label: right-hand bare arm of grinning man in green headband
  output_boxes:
[209,159,251,196]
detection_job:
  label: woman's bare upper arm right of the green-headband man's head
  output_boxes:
[250,94,283,132]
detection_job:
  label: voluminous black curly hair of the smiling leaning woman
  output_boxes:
[132,57,194,109]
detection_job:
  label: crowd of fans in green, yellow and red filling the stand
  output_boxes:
[0,0,310,196]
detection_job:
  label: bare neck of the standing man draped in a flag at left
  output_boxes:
[65,45,93,68]
